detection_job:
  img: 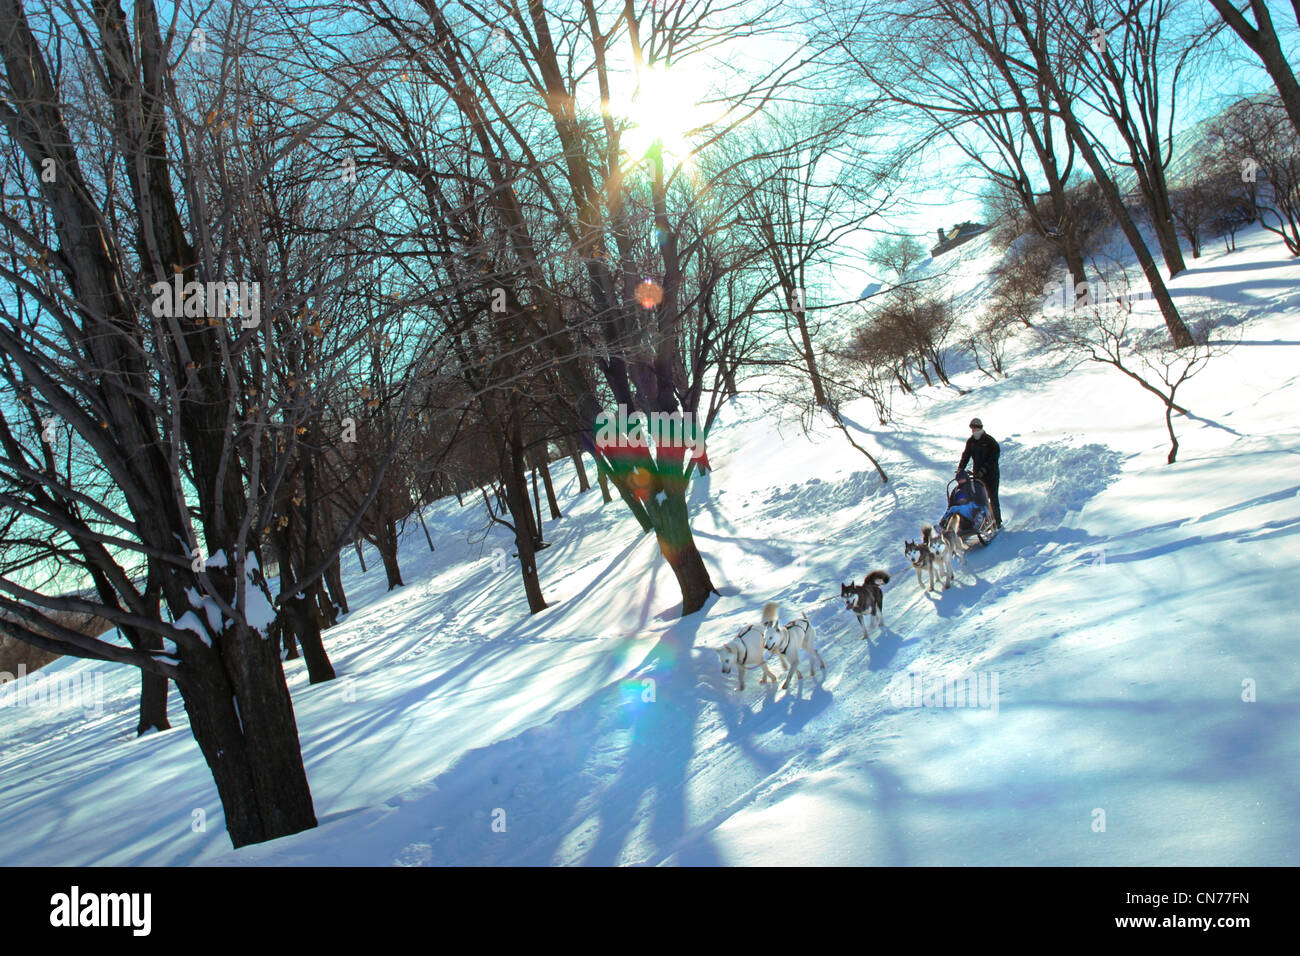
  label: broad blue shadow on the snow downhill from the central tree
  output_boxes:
[351,600,719,866]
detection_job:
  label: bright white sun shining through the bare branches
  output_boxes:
[615,64,716,164]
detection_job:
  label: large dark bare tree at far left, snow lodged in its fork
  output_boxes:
[0,0,431,847]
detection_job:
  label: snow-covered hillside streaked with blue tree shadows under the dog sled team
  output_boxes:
[0,223,1300,865]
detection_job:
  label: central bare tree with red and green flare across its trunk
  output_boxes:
[343,0,832,614]
